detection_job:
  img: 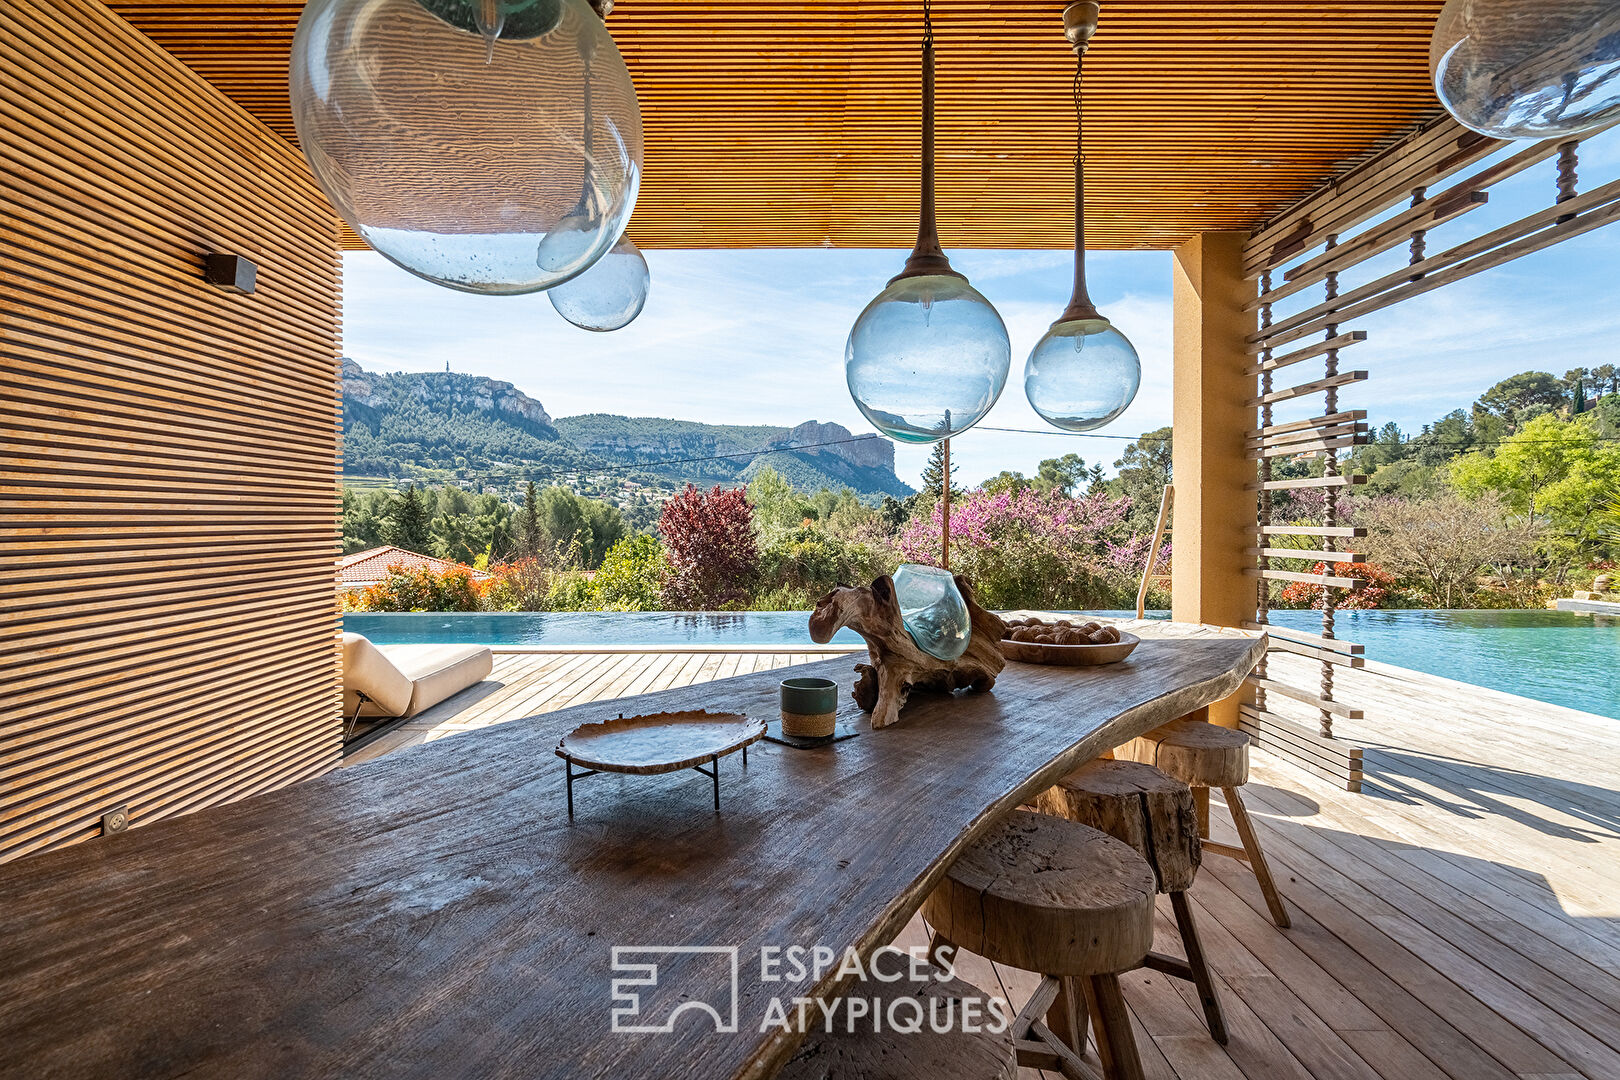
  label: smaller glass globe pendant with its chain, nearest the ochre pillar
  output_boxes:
[1024,2,1142,431]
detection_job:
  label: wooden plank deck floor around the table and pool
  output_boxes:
[345,641,1620,1080]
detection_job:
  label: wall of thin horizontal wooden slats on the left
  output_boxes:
[0,0,342,860]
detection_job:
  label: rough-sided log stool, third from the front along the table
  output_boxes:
[1035,761,1226,1046]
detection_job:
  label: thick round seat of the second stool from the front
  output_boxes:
[923,810,1157,975]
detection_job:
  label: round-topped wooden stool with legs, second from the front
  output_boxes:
[923,810,1155,1080]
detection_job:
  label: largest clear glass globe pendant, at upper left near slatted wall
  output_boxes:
[290,0,642,295]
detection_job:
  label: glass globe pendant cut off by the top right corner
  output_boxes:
[1429,0,1620,139]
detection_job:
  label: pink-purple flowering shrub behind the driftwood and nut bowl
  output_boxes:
[901,489,1170,609]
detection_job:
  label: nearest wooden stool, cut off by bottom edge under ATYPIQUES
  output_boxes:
[776,960,1017,1080]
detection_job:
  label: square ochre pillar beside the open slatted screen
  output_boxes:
[1170,232,1257,727]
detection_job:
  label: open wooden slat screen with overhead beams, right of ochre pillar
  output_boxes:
[1239,117,1620,790]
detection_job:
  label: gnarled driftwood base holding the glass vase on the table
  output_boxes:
[810,575,1006,727]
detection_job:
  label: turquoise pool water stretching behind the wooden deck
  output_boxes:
[343,610,1620,717]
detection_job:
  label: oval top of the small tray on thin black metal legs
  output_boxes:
[557,709,765,776]
